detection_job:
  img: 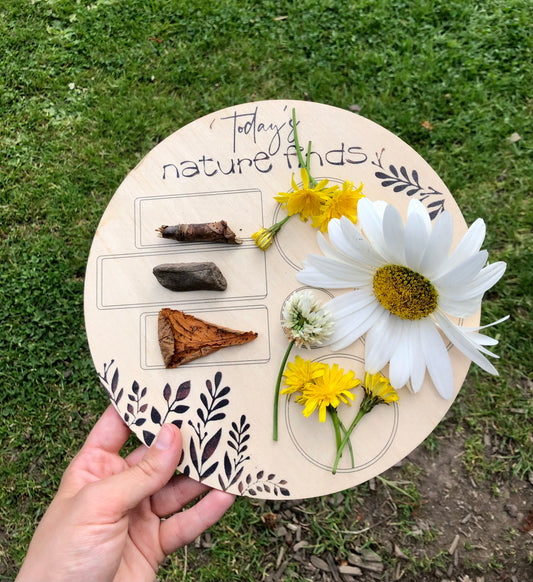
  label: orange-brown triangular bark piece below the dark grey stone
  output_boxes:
[158,308,257,368]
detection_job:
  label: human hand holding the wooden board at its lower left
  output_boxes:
[16,406,234,582]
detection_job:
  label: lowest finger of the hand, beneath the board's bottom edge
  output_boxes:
[159,489,235,555]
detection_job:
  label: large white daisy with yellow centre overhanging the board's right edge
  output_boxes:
[297,198,507,398]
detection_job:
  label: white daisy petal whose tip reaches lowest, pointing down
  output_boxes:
[419,317,454,400]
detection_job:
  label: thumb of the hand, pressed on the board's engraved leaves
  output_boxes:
[100,424,182,512]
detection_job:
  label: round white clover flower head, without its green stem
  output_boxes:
[281,290,333,348]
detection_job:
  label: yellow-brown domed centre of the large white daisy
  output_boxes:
[373,265,438,320]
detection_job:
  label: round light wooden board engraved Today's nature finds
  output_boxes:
[85,101,479,498]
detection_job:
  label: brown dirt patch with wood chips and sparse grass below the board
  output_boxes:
[193,434,533,582]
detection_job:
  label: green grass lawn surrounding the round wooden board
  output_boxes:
[0,0,533,581]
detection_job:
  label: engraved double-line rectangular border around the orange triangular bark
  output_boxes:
[139,305,272,370]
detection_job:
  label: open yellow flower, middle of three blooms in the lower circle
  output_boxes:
[296,364,360,422]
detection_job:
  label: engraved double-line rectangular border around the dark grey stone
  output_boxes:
[96,245,268,310]
